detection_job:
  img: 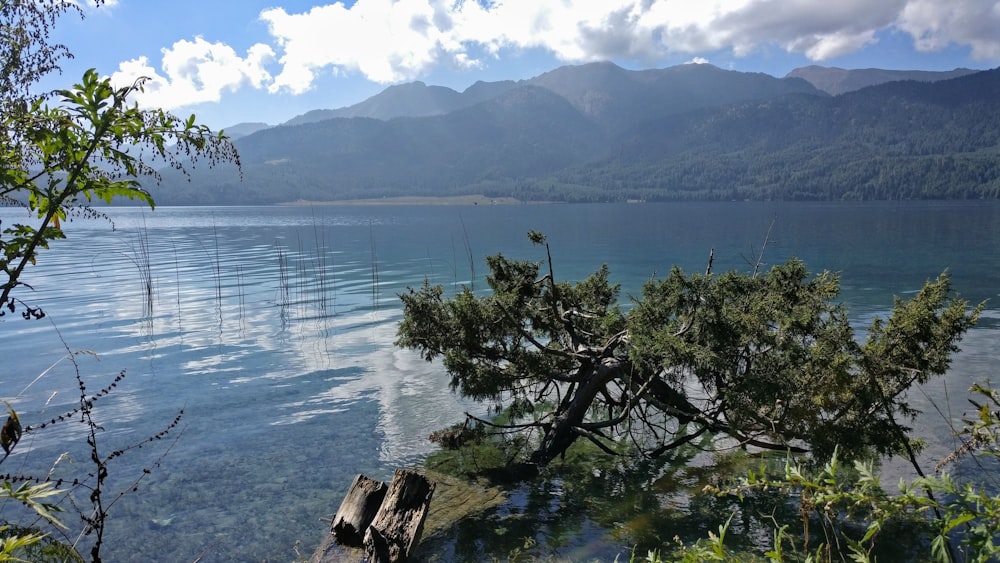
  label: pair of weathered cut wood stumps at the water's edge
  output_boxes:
[310,469,434,563]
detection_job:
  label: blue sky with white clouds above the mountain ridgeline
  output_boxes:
[43,0,1000,129]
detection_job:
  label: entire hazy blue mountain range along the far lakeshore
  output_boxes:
[154,63,1000,204]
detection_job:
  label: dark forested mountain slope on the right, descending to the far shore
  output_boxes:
[548,66,1000,200]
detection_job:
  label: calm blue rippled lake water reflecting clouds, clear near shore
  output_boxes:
[0,203,1000,562]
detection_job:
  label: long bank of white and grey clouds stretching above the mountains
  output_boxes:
[112,0,1000,102]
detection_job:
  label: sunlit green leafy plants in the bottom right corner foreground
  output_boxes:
[660,384,1000,563]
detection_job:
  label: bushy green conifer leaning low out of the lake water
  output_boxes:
[397,232,981,466]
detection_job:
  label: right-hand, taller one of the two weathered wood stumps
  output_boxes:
[364,469,434,563]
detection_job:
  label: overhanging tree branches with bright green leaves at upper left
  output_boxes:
[0,0,239,317]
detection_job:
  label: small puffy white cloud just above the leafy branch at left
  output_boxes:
[111,37,274,109]
